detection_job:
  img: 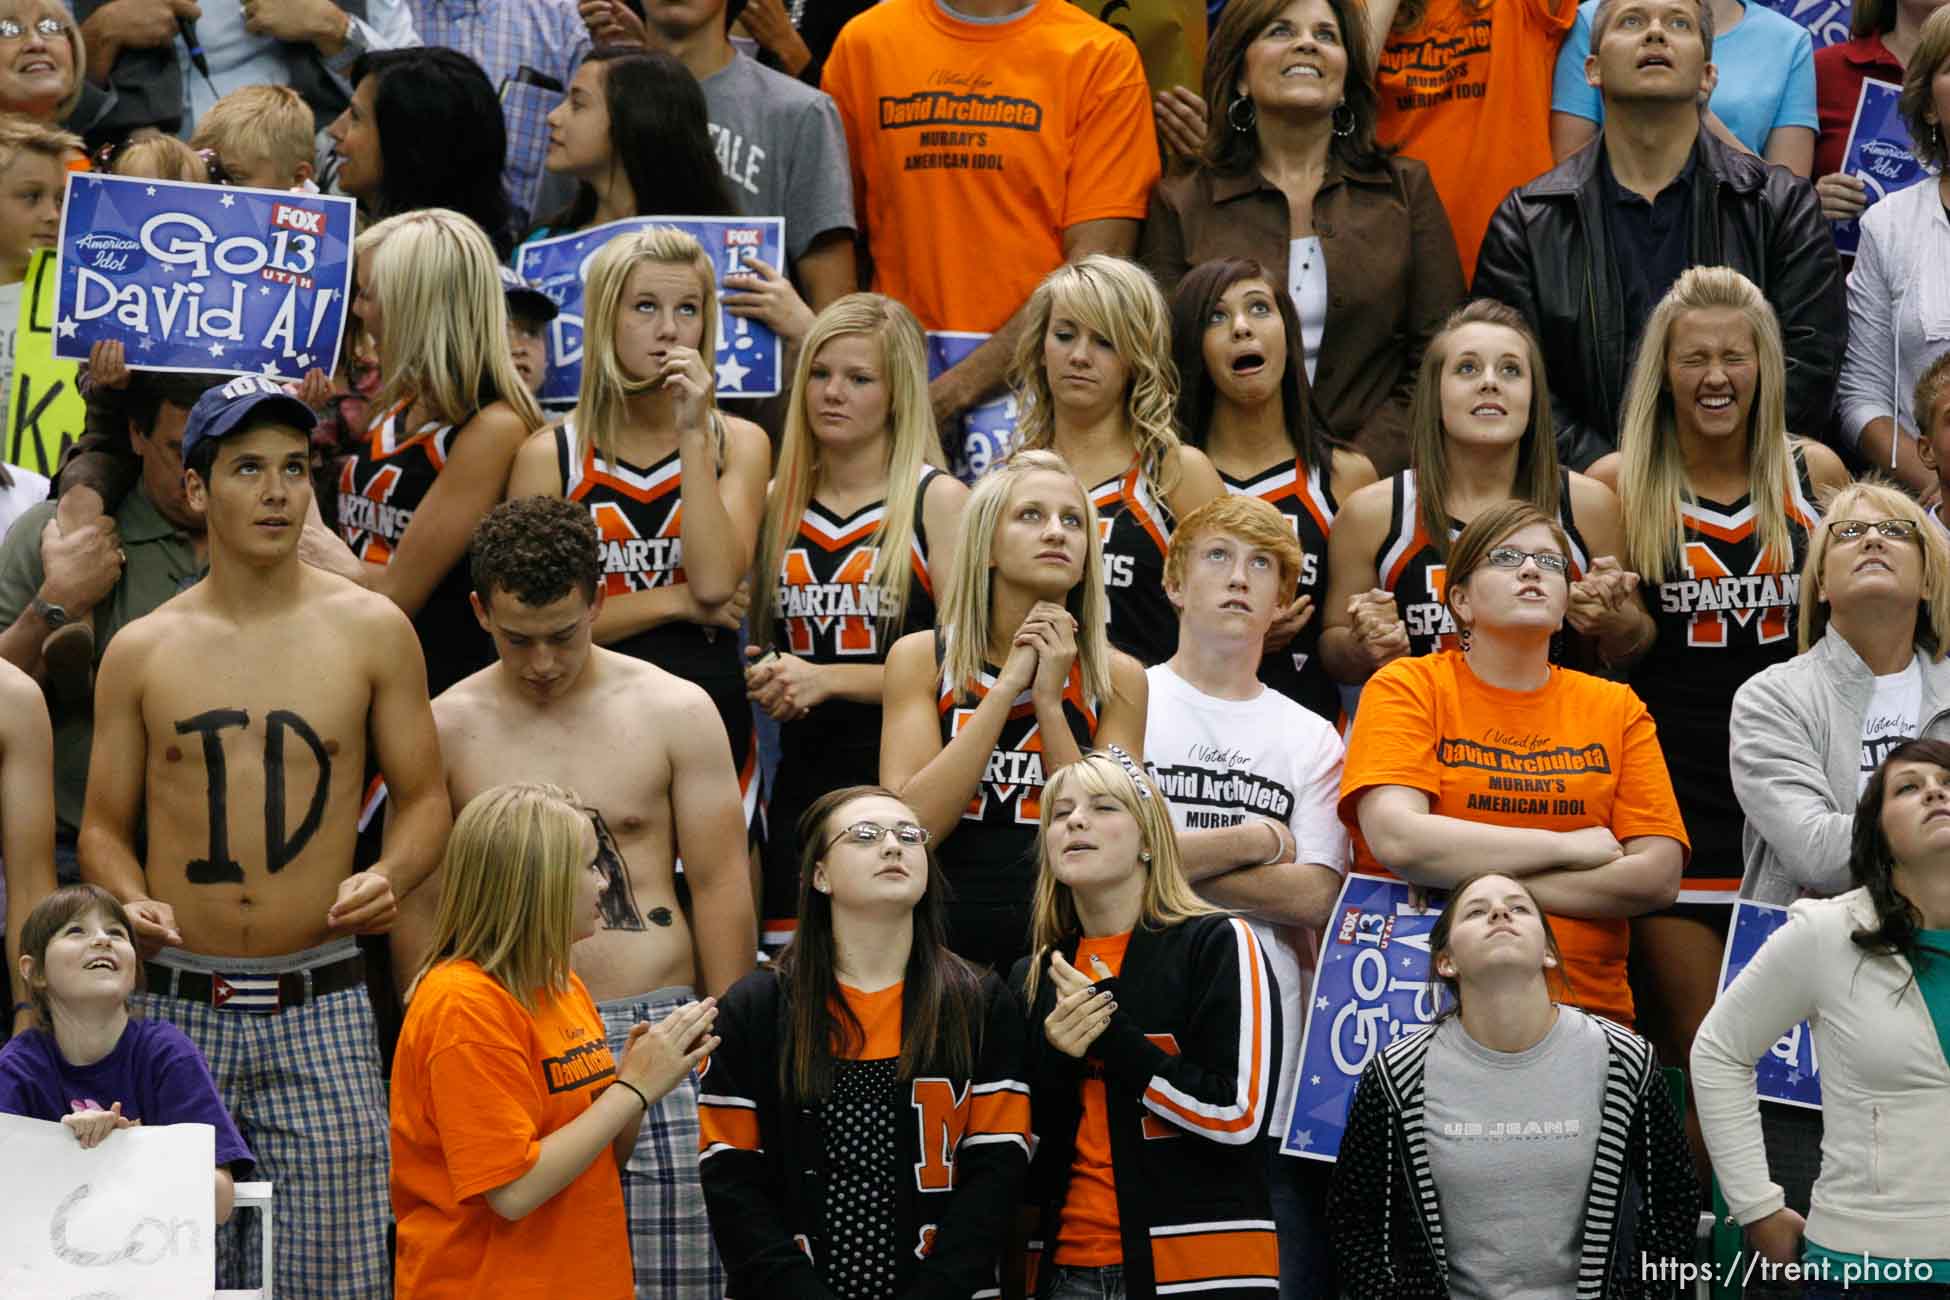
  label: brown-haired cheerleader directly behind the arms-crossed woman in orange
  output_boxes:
[1320,298,1652,686]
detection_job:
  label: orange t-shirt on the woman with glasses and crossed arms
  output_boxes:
[1340,651,1687,1025]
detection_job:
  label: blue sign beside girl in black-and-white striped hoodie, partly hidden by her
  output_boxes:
[1279,875,1443,1160]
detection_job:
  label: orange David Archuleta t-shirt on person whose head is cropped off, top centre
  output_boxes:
[823,0,1154,333]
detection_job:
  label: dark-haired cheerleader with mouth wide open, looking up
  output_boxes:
[1172,257,1375,721]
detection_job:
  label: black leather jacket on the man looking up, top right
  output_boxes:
[1472,131,1849,470]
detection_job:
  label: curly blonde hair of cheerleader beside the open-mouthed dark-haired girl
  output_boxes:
[1008,253,1180,507]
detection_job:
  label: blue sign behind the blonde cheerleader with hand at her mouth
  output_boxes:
[515,216,786,409]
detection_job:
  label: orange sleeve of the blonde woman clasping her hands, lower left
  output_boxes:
[427,986,544,1201]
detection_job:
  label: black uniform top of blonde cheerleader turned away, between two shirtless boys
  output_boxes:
[337,403,495,696]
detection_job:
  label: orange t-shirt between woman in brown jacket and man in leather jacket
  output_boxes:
[1375,0,1578,279]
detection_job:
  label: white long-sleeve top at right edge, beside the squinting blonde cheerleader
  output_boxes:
[1837,179,1950,444]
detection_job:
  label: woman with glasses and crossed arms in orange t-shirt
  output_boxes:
[1340,501,1687,1025]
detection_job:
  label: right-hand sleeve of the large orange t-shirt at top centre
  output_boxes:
[1061,37,1162,230]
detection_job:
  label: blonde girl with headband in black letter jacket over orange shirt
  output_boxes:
[1010,746,1281,1300]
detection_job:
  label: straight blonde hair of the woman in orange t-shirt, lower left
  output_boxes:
[413,785,595,1012]
